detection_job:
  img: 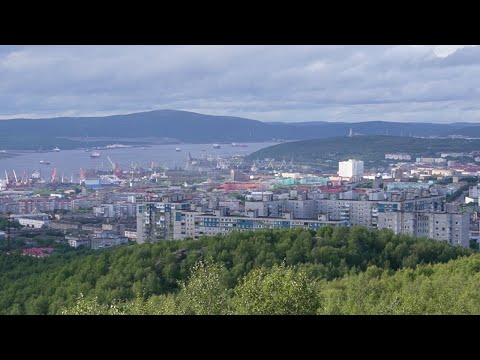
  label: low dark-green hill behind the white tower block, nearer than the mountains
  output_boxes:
[249,135,480,162]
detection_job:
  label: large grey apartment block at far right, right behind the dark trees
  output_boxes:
[378,211,470,248]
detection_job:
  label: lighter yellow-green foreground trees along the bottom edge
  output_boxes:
[62,254,480,315]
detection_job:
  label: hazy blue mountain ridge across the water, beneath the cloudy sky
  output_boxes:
[0,110,480,149]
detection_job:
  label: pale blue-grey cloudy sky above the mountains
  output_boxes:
[0,45,480,123]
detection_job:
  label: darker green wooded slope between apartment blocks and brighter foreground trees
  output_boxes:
[0,227,473,314]
